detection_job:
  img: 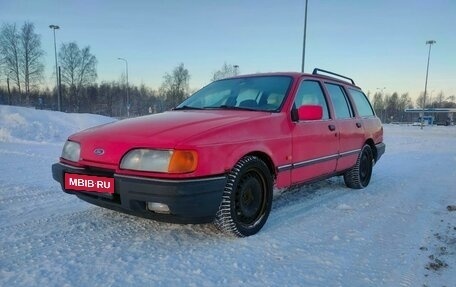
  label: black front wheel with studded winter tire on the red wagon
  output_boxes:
[214,156,273,237]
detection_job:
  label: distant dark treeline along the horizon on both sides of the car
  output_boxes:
[0,75,456,123]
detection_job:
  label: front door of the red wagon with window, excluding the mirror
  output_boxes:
[291,80,339,183]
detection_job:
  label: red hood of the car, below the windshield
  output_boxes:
[70,110,271,164]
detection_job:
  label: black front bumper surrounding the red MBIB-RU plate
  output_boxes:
[52,163,226,223]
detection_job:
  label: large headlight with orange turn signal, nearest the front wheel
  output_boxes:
[120,149,198,173]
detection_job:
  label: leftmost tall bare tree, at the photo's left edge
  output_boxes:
[0,24,21,94]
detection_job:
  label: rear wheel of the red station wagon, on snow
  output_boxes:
[344,144,374,189]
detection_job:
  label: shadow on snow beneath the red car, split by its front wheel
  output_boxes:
[85,177,352,243]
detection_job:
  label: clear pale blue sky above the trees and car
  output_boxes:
[0,0,456,102]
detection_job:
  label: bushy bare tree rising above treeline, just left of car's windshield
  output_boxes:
[160,63,190,108]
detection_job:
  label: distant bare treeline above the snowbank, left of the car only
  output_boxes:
[0,64,190,117]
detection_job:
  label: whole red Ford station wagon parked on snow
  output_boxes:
[52,69,385,237]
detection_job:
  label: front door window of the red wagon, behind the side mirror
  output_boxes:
[294,81,329,120]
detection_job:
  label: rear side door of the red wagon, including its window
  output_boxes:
[324,82,364,171]
